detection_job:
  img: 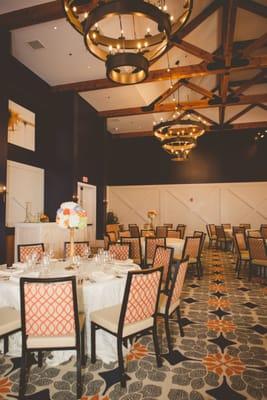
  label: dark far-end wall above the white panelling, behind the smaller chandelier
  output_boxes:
[108,132,267,185]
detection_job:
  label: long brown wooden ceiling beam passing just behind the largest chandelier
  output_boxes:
[52,55,267,92]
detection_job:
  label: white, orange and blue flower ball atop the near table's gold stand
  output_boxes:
[56,201,87,229]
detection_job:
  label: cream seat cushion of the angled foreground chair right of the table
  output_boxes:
[90,304,153,337]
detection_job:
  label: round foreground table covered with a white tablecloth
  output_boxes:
[0,260,140,365]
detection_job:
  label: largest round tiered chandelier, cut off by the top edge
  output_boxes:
[63,0,193,84]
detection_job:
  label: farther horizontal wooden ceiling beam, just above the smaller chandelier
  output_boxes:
[98,94,267,118]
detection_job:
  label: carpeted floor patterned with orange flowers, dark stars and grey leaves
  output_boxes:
[0,250,267,400]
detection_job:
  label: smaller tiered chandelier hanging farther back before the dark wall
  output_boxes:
[153,115,205,161]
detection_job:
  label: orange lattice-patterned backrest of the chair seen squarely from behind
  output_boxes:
[20,276,79,345]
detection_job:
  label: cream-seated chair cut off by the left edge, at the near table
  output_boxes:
[0,307,21,354]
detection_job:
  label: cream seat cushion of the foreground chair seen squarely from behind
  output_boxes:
[27,313,85,349]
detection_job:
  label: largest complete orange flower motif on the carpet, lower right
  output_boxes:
[203,353,246,376]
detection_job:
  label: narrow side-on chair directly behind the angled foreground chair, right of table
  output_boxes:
[157,257,191,353]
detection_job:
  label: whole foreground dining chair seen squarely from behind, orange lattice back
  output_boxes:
[19,276,85,399]
